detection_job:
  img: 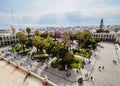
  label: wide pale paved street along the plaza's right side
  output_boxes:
[84,43,120,86]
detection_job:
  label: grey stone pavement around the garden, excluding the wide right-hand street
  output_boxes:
[2,47,100,86]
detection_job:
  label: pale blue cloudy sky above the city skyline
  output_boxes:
[0,0,120,27]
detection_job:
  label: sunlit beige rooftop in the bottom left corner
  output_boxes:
[0,57,54,86]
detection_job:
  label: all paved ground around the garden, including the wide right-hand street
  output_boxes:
[0,43,120,86]
